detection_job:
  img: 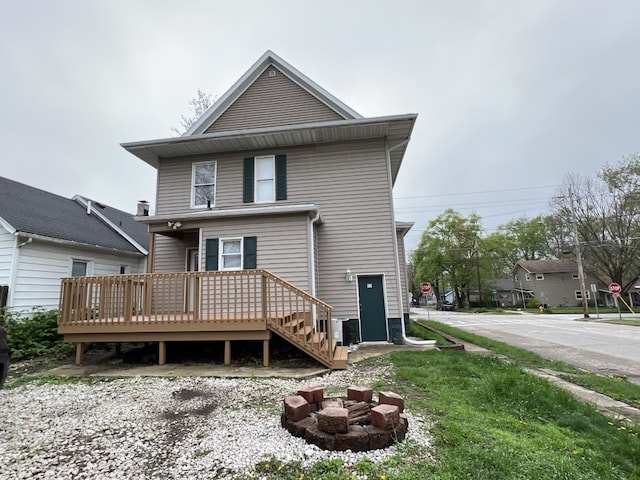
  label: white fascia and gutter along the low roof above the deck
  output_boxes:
[134,204,322,224]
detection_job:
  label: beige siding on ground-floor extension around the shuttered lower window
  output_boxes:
[202,214,310,291]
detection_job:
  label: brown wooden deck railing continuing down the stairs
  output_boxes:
[58,270,335,362]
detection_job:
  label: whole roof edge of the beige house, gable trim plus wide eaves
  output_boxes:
[121,51,418,182]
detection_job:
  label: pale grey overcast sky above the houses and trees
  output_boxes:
[0,0,640,249]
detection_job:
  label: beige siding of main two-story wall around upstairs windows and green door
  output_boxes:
[156,139,402,318]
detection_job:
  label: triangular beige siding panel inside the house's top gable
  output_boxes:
[205,67,343,133]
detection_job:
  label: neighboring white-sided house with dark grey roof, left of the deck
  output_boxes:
[0,177,149,311]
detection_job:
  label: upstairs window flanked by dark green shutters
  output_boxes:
[242,155,287,203]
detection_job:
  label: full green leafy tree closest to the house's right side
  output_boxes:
[413,209,481,305]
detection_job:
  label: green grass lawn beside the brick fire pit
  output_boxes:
[236,350,640,480]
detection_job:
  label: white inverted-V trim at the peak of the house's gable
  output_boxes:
[188,50,363,136]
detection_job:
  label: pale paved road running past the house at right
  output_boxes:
[412,308,640,384]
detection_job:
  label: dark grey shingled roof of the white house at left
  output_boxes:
[0,177,149,254]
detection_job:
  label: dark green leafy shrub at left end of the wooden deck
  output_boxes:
[0,308,73,360]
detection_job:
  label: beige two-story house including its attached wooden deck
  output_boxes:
[60,51,417,368]
